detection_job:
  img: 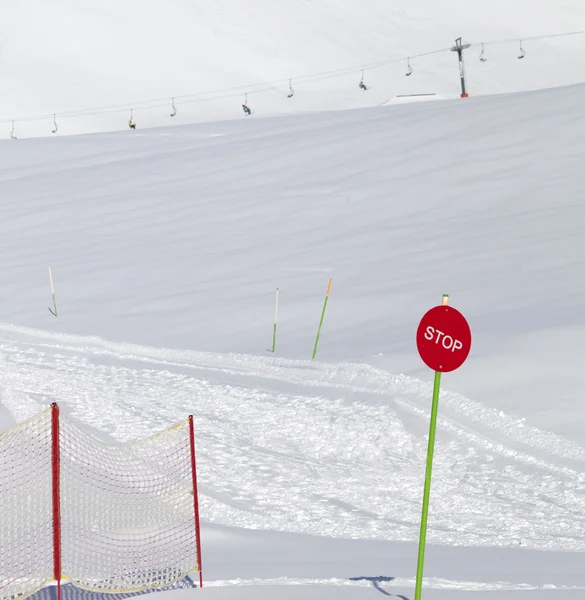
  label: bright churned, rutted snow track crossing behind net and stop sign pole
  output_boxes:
[0,325,585,551]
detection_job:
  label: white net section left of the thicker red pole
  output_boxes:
[0,409,53,600]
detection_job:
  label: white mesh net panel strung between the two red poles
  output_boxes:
[61,417,198,592]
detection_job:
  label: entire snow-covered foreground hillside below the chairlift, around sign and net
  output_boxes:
[0,75,585,600]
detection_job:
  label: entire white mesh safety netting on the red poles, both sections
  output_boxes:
[0,410,200,600]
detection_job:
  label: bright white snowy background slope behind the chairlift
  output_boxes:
[0,0,585,137]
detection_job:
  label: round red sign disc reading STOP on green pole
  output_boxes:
[416,306,471,373]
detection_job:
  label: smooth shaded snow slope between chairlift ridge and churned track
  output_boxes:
[0,81,585,440]
